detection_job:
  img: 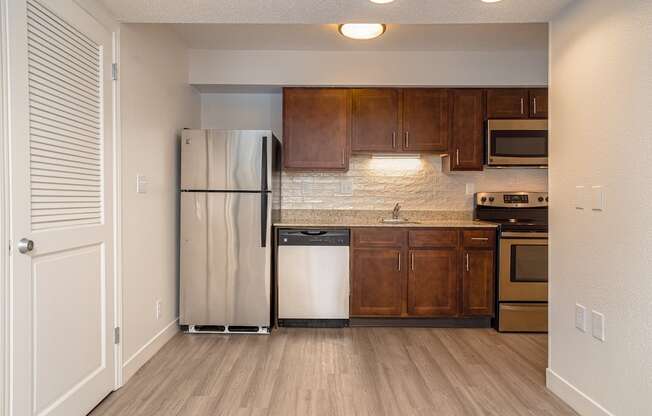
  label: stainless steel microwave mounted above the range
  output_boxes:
[486,120,548,167]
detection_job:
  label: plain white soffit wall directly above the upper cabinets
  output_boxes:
[189,49,548,86]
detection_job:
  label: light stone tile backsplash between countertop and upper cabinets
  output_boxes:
[282,155,548,211]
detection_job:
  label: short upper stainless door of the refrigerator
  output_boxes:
[181,130,274,191]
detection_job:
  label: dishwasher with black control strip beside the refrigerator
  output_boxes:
[277,229,350,327]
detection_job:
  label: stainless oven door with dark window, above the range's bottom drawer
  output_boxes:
[498,233,548,302]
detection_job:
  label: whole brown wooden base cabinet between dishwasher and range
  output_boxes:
[351,227,496,318]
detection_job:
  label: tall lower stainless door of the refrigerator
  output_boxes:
[179,192,271,326]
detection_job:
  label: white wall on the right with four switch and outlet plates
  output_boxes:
[548,0,652,416]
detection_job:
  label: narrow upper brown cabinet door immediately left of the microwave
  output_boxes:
[450,89,484,170]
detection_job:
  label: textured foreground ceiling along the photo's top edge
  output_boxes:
[101,0,573,24]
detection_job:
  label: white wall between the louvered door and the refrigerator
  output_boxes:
[120,24,200,379]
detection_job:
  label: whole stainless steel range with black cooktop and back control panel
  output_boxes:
[474,192,548,332]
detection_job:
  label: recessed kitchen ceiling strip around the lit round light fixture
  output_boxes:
[170,23,548,51]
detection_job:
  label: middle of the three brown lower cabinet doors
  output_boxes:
[408,249,459,317]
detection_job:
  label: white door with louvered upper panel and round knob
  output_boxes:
[8,0,115,416]
